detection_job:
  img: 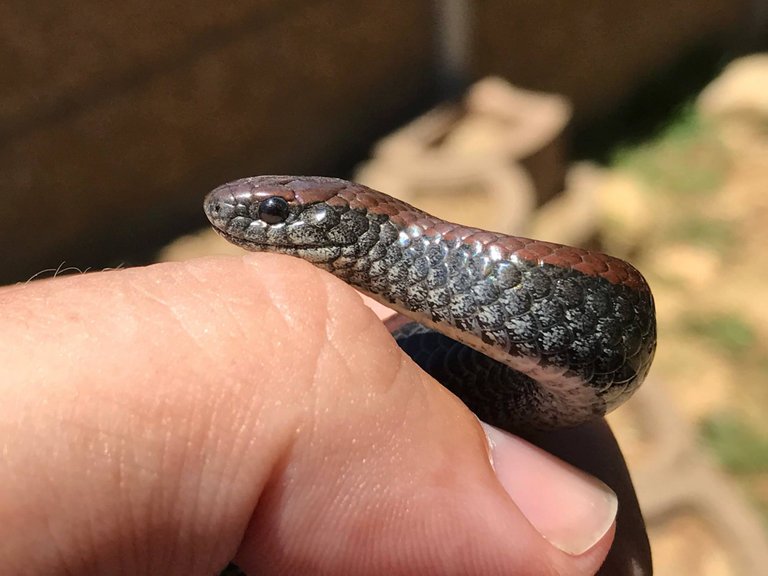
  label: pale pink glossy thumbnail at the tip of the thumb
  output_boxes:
[481,422,618,555]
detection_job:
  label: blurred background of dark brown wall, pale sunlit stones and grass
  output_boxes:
[0,0,768,576]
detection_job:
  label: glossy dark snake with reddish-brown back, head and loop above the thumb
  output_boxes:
[204,176,656,432]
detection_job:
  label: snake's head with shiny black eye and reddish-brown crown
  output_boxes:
[204,176,371,264]
